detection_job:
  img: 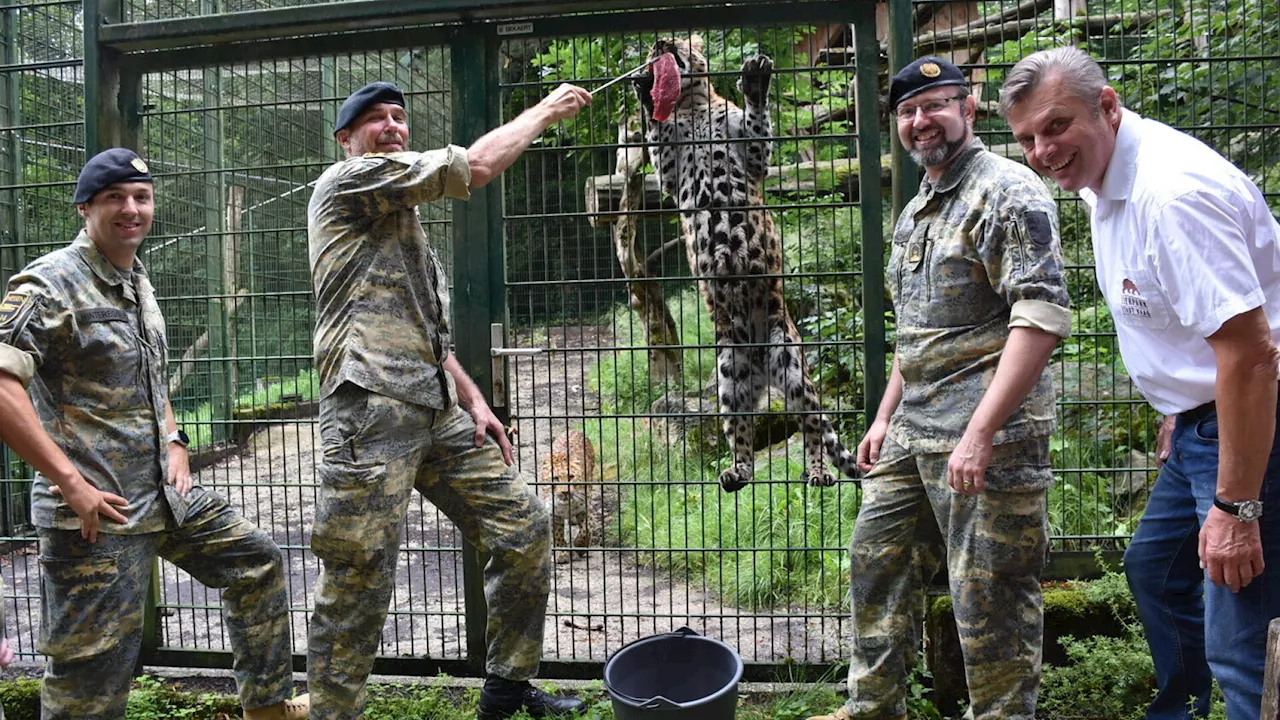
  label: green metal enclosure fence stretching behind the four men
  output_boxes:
[0,0,1280,678]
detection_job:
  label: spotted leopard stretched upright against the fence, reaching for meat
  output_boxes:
[635,36,858,492]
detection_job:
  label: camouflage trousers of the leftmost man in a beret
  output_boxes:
[36,487,293,720]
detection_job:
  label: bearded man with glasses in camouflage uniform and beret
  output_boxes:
[808,58,1070,720]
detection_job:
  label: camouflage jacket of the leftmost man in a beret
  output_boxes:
[0,231,185,534]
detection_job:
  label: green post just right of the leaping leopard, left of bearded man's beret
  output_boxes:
[850,3,886,425]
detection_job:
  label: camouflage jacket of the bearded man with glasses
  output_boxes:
[887,140,1071,454]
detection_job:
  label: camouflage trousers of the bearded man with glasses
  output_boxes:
[846,430,1053,720]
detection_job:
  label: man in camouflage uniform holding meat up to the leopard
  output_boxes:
[307,82,590,720]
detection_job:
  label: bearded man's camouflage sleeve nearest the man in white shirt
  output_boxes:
[984,182,1071,338]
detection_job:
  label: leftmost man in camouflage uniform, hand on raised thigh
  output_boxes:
[0,147,307,720]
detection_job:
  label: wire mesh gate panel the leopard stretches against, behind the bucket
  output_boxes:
[503,14,879,662]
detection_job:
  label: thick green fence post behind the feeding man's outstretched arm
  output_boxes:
[449,26,508,671]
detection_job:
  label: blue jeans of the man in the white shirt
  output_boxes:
[1124,413,1280,720]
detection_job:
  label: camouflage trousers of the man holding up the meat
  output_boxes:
[307,383,550,720]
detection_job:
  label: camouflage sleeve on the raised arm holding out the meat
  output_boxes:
[334,145,471,215]
